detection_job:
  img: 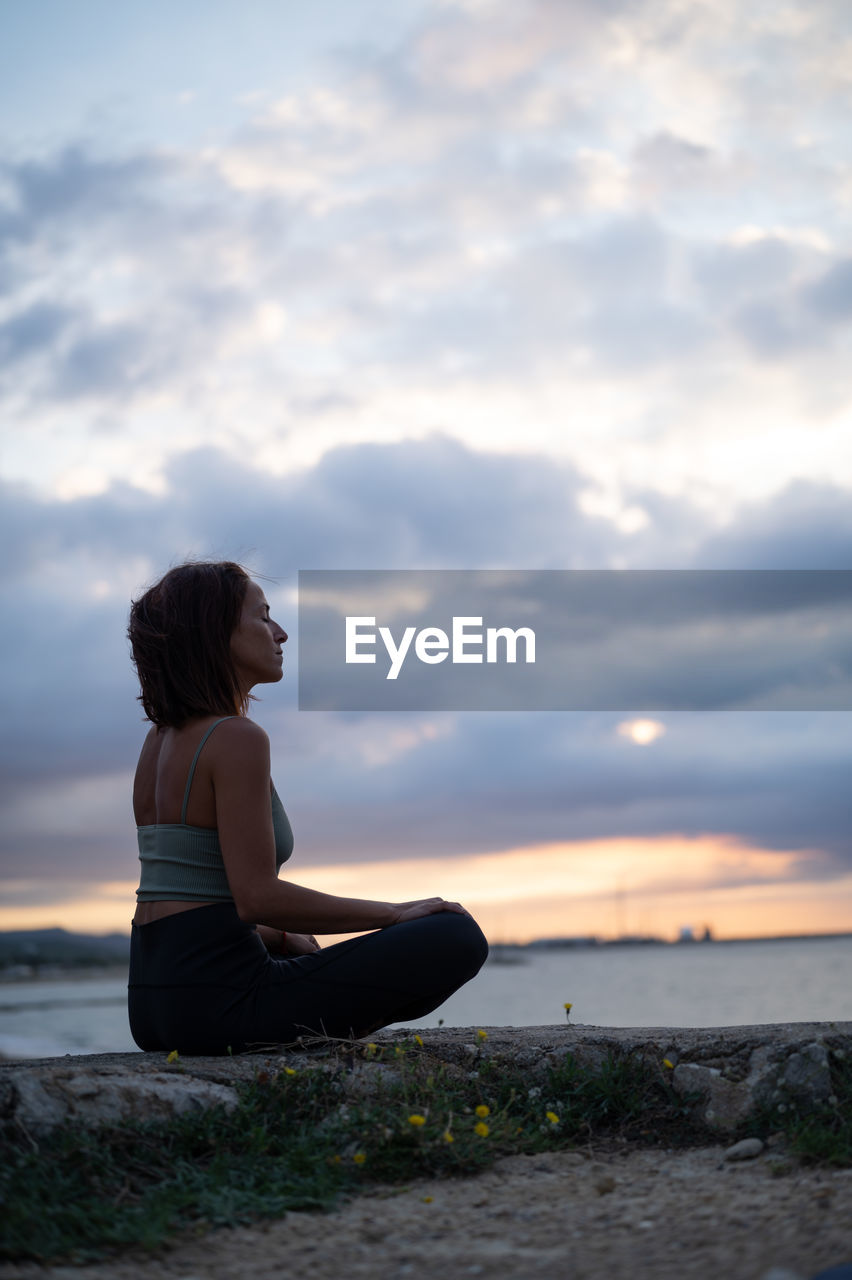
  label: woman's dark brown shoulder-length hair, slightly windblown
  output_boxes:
[127,561,249,728]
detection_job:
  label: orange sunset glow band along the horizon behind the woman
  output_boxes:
[0,836,852,942]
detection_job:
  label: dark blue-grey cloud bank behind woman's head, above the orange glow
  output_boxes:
[0,438,852,901]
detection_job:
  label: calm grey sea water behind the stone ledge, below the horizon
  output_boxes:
[0,934,852,1059]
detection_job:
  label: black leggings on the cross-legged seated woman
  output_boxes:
[128,902,489,1053]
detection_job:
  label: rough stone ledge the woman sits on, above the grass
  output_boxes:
[0,1023,852,1134]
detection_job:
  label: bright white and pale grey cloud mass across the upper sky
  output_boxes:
[0,3,852,500]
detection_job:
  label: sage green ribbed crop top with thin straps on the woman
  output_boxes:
[136,716,293,902]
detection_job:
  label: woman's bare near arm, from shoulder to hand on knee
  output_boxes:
[210,721,467,934]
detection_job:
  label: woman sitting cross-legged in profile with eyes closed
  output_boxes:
[128,562,487,1053]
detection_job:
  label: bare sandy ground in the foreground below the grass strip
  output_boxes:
[0,1146,852,1280]
